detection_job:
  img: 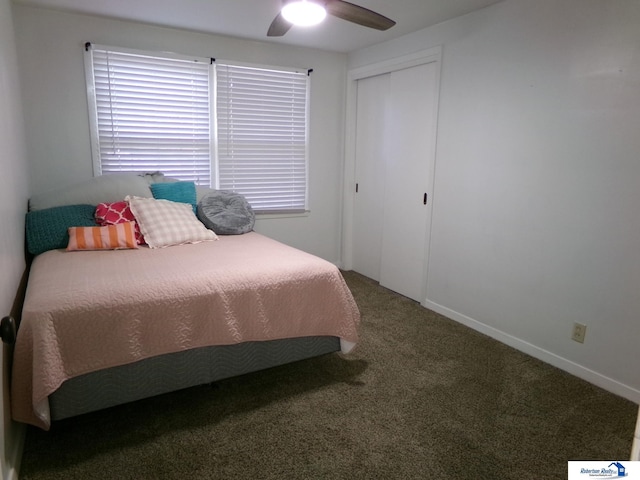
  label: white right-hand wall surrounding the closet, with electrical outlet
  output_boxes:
[347,0,640,402]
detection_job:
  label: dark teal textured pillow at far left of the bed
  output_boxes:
[25,205,96,255]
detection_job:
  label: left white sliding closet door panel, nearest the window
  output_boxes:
[352,74,391,281]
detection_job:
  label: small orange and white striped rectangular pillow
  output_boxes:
[67,222,138,251]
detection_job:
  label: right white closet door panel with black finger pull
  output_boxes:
[380,62,437,302]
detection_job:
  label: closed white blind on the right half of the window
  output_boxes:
[215,64,309,212]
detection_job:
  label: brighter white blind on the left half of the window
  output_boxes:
[87,45,212,185]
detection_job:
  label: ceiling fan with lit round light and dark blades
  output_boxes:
[267,0,396,37]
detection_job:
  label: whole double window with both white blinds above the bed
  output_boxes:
[86,45,309,213]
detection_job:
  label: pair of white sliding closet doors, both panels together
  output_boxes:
[353,62,437,302]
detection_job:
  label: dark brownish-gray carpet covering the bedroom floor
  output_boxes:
[20,272,637,480]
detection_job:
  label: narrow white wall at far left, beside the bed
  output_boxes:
[0,0,29,480]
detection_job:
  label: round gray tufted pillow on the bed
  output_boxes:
[197,190,256,235]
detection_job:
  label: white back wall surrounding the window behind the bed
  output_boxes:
[14,5,346,262]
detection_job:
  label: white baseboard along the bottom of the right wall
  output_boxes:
[422,300,640,404]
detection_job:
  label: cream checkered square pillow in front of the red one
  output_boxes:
[125,196,218,248]
